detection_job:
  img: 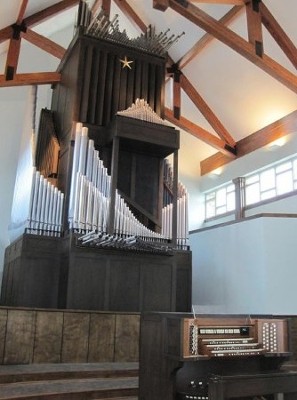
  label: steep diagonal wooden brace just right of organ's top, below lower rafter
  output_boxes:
[180,74,235,146]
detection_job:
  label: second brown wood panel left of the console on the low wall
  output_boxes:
[88,314,116,362]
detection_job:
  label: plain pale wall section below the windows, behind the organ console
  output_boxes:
[191,218,297,315]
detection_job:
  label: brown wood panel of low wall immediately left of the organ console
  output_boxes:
[114,314,140,362]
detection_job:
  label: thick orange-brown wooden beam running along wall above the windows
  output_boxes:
[200,110,297,175]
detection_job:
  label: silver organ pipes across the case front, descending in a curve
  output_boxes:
[68,123,188,247]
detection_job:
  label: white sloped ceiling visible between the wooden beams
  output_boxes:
[0,0,297,176]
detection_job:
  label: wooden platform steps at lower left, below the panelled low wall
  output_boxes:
[0,363,138,400]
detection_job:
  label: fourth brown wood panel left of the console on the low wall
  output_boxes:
[33,311,63,363]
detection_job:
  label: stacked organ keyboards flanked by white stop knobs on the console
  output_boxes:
[182,318,288,358]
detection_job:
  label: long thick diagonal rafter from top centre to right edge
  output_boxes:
[164,0,297,93]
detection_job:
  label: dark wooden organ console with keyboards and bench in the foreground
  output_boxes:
[139,313,297,400]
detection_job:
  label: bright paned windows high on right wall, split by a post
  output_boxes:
[205,155,297,219]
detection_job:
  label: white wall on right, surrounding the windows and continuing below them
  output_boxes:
[190,133,297,314]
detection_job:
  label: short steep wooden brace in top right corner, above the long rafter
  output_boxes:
[260,2,297,68]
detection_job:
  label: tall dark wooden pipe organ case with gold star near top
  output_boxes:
[1,2,191,312]
